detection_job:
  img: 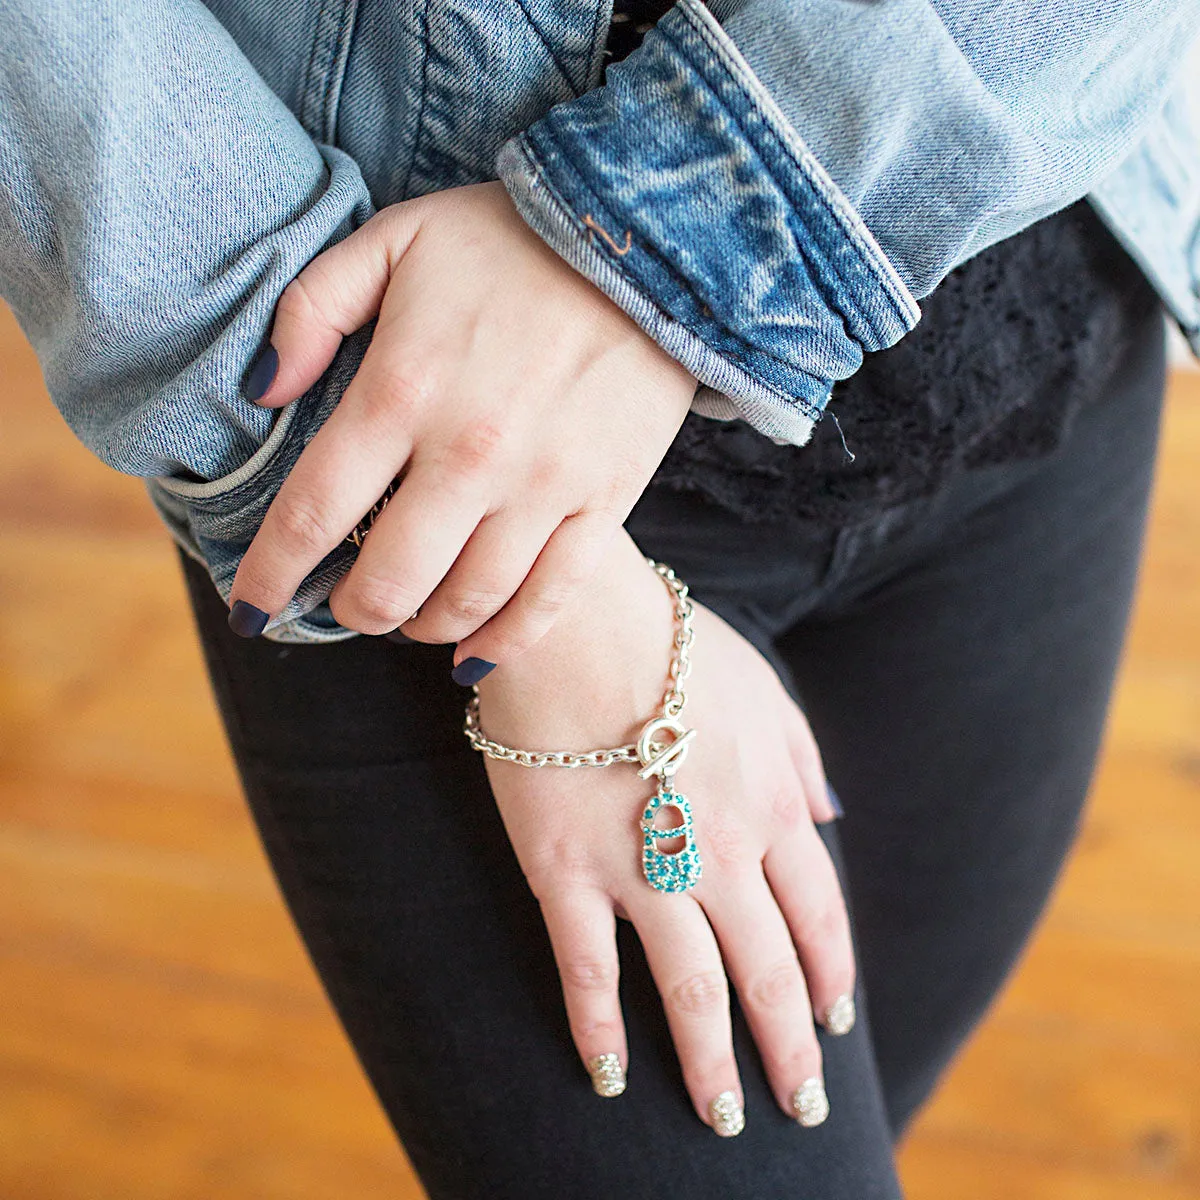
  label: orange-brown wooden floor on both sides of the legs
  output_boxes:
[0,297,1200,1200]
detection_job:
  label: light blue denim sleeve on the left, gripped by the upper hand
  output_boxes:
[0,0,373,641]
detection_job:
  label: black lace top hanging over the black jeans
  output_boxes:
[608,0,1159,526]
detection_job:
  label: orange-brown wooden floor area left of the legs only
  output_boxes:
[0,306,424,1200]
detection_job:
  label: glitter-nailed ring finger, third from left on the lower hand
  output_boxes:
[703,870,828,1124]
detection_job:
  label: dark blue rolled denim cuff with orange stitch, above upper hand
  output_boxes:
[494,0,920,445]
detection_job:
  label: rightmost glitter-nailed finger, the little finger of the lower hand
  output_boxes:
[763,822,856,1034]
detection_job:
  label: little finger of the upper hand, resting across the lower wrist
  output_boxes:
[454,509,620,666]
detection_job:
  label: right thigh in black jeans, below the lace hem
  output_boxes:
[778,307,1163,1138]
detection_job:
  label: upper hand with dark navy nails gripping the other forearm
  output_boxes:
[230,181,696,664]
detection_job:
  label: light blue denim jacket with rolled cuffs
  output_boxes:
[7,0,1200,642]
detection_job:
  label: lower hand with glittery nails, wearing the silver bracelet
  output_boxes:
[479,530,854,1135]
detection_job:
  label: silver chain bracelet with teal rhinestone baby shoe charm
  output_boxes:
[462,558,701,892]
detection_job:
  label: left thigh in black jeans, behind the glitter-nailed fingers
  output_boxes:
[177,530,900,1200]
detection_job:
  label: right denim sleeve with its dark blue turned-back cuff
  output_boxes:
[496,0,1200,445]
